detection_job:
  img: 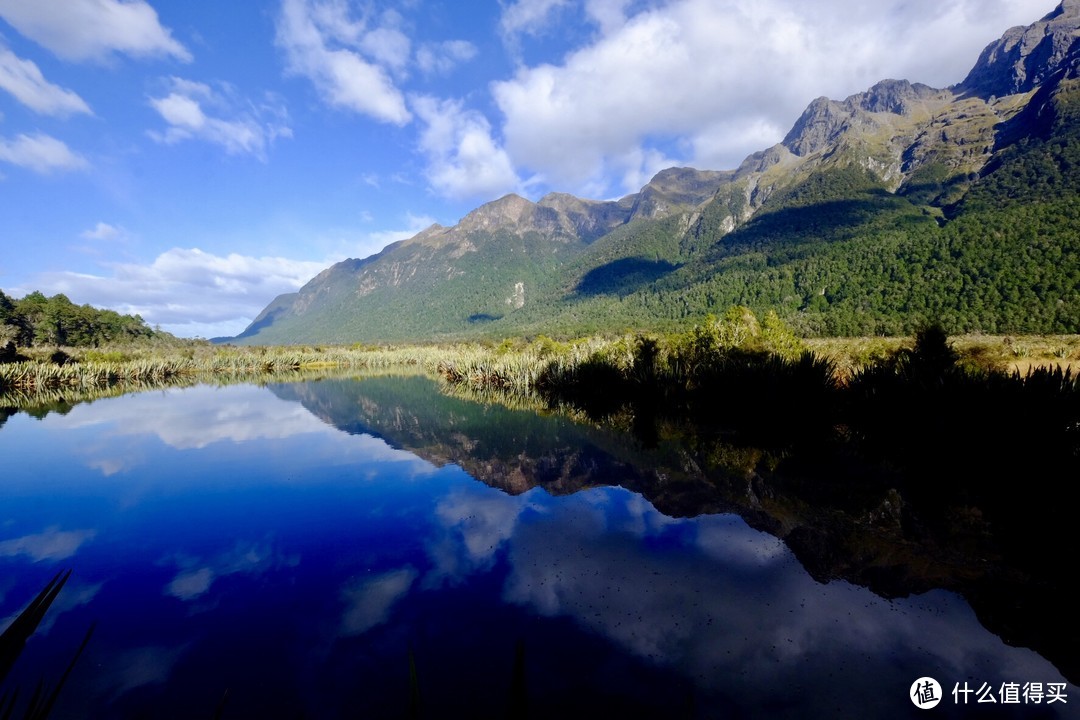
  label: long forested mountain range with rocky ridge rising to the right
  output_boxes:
[234,0,1080,343]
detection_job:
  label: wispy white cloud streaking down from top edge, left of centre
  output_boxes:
[276,0,411,125]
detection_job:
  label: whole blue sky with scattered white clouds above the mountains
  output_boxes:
[0,0,1056,338]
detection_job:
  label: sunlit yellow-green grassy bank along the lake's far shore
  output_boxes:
[0,315,1080,395]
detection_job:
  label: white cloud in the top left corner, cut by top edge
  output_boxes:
[0,0,191,62]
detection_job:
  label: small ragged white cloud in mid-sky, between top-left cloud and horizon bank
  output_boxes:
[150,78,293,161]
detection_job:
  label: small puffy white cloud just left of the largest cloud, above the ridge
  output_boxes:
[413,96,521,199]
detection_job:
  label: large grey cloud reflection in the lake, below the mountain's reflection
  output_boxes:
[416,486,1056,708]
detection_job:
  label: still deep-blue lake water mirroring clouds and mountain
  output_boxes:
[0,376,1080,719]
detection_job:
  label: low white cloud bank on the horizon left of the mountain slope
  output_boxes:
[19,247,327,337]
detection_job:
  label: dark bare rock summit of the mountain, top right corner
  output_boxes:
[958,0,1080,97]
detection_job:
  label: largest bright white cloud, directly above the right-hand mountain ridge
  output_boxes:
[491,0,1050,197]
